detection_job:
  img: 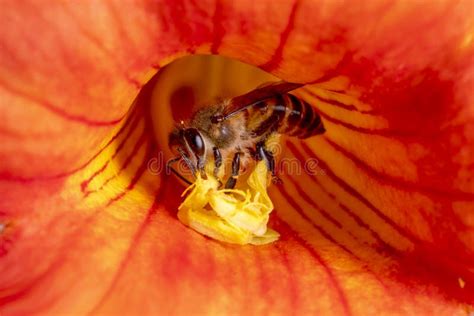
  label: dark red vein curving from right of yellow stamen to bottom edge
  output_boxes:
[277,215,352,315]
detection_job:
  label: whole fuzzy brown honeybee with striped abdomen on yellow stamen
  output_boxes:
[167,81,325,189]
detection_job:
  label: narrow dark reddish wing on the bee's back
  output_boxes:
[213,81,304,122]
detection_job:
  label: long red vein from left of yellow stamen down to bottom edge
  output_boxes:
[88,179,167,315]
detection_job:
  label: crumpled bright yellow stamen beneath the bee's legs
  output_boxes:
[178,161,279,245]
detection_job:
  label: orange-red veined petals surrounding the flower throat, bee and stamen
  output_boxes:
[0,0,474,315]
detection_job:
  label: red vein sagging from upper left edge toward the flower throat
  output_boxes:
[0,79,127,127]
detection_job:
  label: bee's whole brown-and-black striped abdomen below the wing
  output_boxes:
[247,94,325,138]
